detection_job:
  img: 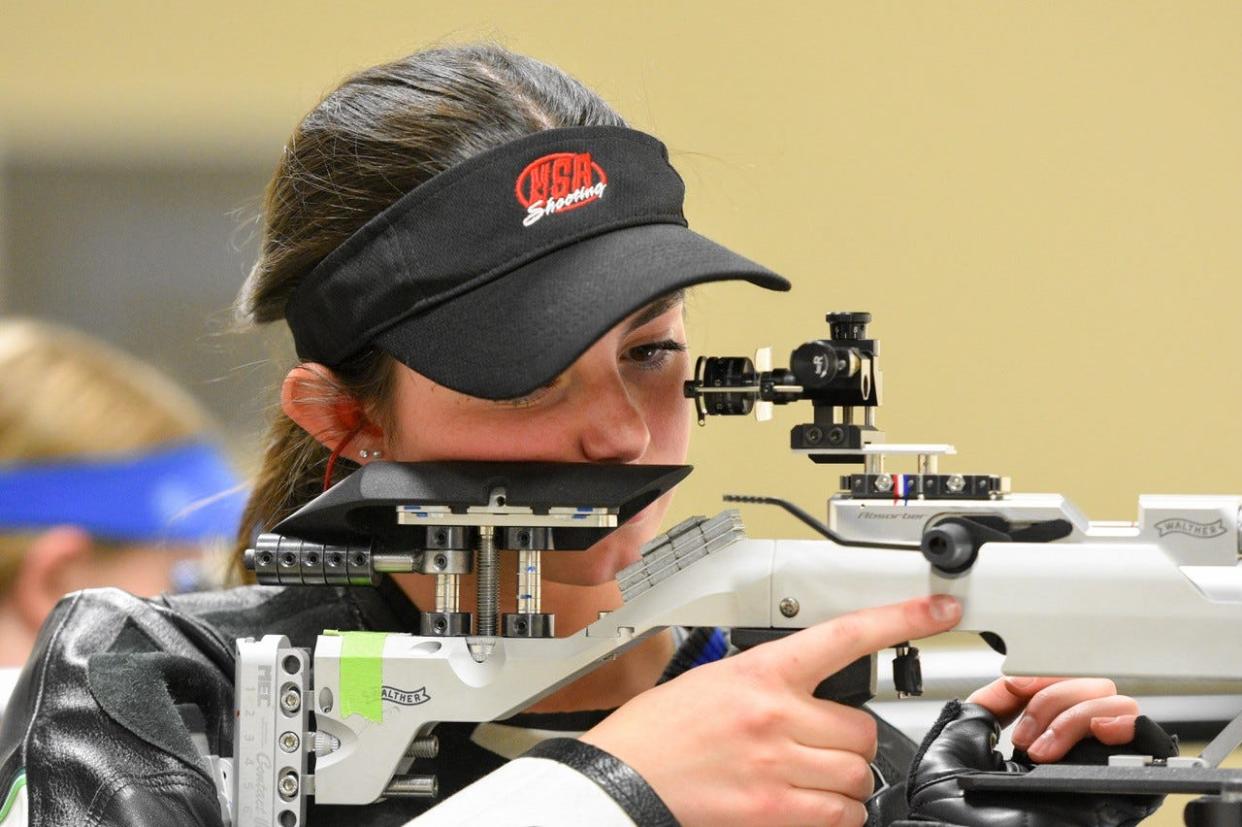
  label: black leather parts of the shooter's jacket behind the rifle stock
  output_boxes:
[0,581,915,827]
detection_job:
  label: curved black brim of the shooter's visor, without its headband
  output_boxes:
[375,224,790,399]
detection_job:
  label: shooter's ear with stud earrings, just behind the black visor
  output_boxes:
[281,361,384,454]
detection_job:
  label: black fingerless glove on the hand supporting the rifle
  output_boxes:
[892,700,1177,827]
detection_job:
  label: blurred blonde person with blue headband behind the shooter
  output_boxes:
[0,319,245,712]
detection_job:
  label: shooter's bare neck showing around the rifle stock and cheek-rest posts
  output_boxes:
[394,551,673,712]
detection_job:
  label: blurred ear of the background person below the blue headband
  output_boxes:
[11,525,93,635]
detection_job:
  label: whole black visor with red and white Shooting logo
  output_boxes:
[286,127,789,399]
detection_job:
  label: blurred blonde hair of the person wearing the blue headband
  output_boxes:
[0,318,210,594]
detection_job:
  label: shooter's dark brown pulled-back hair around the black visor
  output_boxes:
[237,45,625,573]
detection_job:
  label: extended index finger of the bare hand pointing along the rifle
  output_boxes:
[763,595,961,692]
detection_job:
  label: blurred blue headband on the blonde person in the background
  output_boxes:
[0,442,246,543]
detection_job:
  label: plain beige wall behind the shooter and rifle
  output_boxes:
[0,0,1242,535]
